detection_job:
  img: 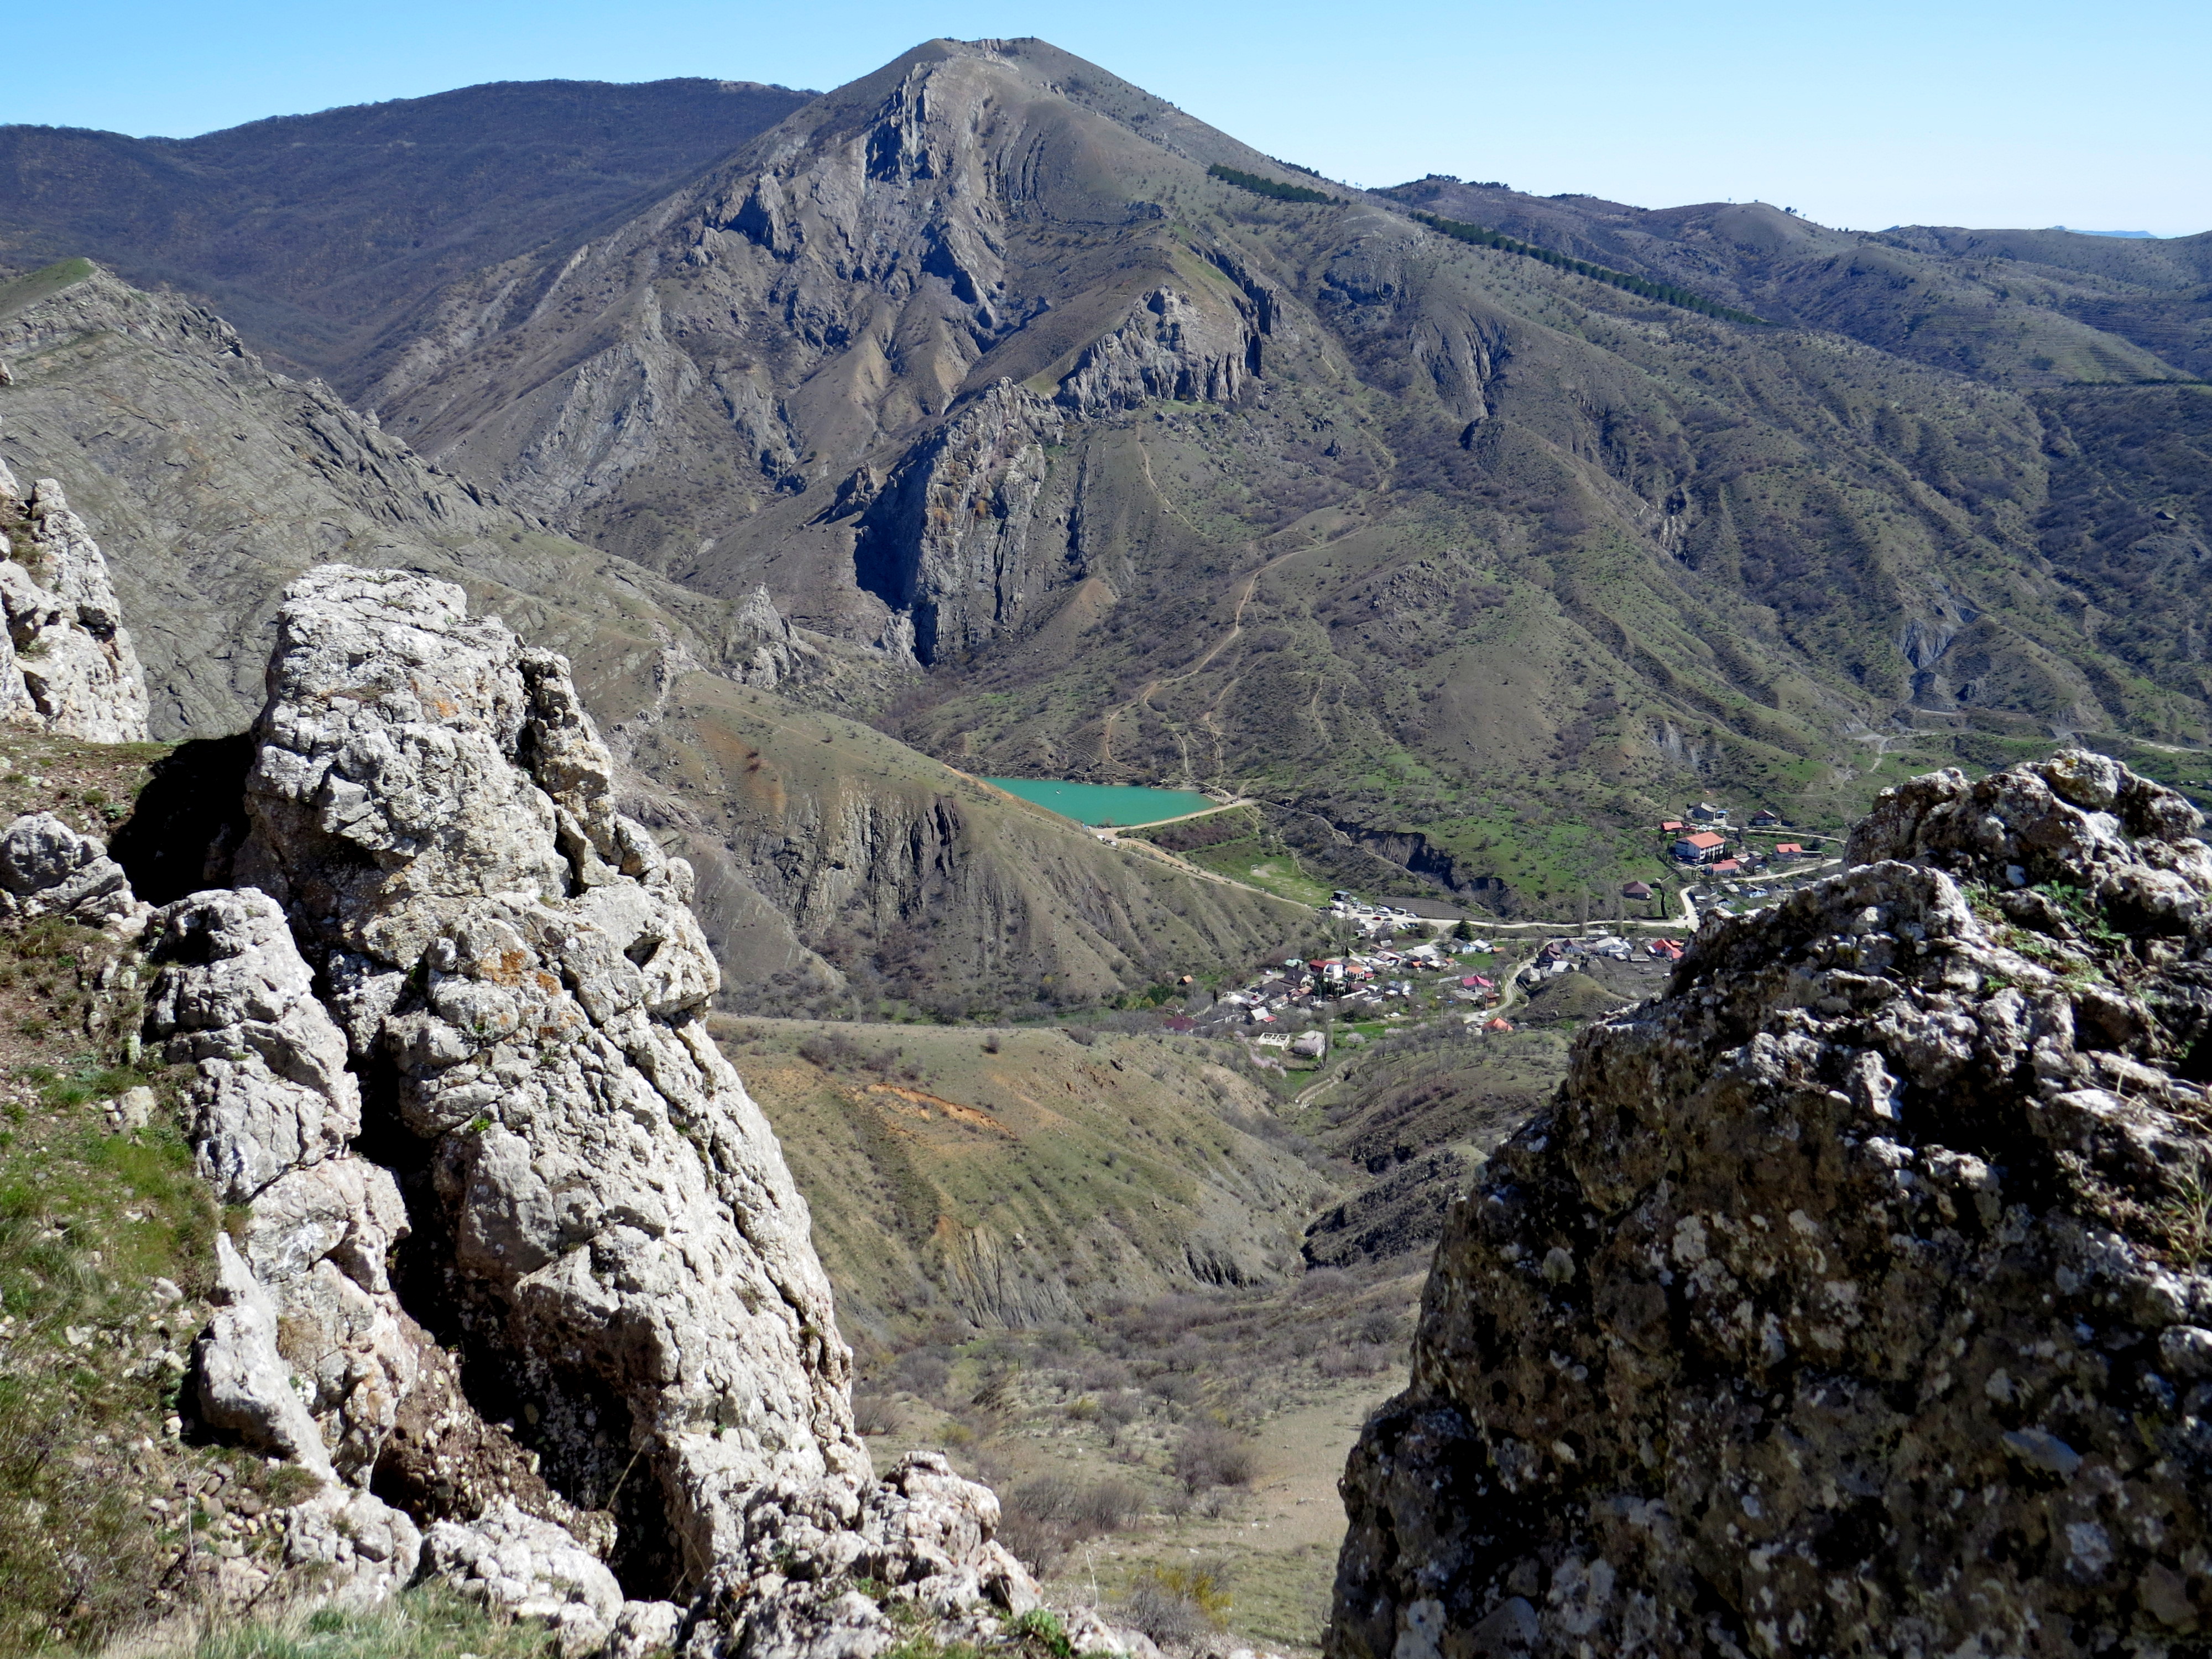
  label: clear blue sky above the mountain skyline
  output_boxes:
[0,0,2212,234]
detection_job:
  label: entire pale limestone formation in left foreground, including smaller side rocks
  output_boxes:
[0,566,1150,1659]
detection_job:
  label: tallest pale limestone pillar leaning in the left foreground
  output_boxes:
[239,566,867,1588]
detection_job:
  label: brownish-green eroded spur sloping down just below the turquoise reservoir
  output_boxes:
[630,675,1314,1018]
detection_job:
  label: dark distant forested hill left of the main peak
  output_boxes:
[0,80,812,389]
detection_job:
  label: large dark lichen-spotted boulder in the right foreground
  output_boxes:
[1329,752,2212,1659]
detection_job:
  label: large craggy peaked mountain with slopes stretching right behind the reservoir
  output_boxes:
[276,40,2212,911]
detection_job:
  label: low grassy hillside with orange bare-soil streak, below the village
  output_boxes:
[717,1020,1336,1343]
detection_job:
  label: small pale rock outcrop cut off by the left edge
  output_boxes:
[0,465,146,743]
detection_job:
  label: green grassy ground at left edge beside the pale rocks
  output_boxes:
[0,734,321,1652]
